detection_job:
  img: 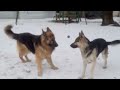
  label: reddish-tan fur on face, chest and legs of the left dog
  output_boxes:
[17,28,58,76]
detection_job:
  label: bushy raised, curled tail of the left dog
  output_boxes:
[4,25,18,39]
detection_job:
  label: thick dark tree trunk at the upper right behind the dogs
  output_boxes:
[102,11,119,26]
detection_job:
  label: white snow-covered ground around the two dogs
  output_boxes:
[0,18,120,79]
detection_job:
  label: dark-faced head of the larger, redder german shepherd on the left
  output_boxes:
[42,27,58,48]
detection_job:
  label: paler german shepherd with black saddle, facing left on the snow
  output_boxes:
[70,31,120,79]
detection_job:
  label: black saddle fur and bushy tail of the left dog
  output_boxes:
[4,25,41,54]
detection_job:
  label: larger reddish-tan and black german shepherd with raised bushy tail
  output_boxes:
[4,25,58,76]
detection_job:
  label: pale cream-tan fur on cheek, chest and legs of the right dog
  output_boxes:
[77,33,108,79]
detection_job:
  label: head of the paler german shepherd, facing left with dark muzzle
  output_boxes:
[70,31,89,48]
